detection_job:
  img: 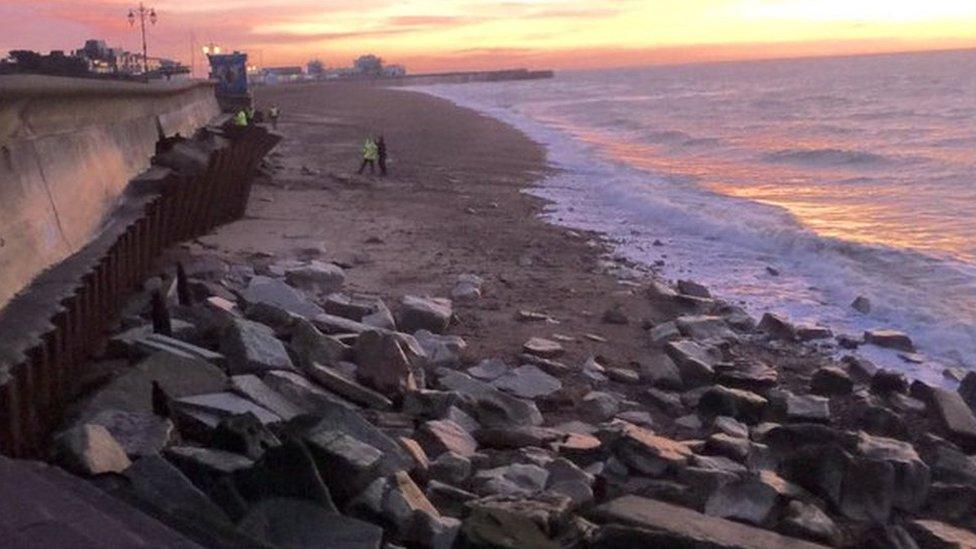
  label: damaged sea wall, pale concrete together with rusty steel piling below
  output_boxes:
[0,78,280,457]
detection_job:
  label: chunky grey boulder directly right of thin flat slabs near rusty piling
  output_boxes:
[220,319,295,375]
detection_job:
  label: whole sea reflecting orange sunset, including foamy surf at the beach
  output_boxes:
[422,50,976,385]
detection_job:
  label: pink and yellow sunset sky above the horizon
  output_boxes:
[0,0,976,72]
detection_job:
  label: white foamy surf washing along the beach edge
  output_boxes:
[418,80,973,389]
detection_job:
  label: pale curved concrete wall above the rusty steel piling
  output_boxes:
[0,76,219,309]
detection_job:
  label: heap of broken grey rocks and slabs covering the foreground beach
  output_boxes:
[53,261,976,549]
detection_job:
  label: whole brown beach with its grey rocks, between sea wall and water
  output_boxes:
[51,79,976,549]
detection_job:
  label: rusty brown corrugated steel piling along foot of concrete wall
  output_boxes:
[0,126,280,458]
